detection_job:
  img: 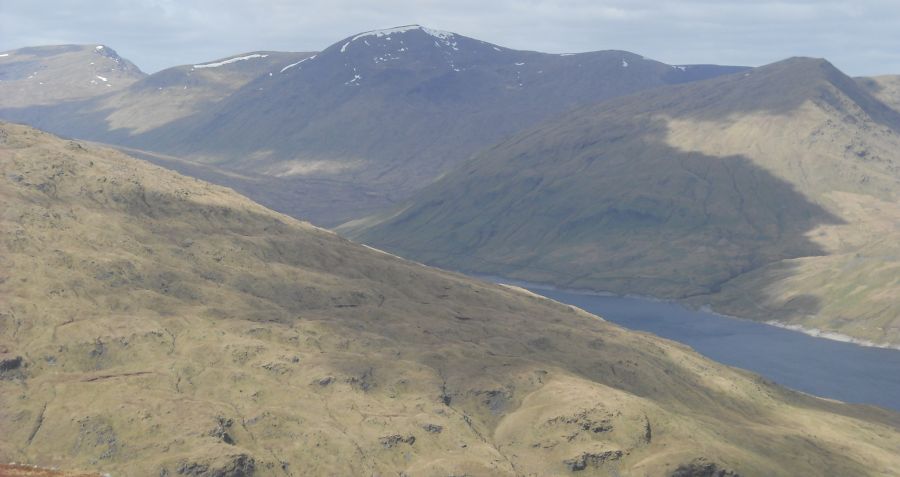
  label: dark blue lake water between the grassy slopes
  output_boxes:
[532,288,900,411]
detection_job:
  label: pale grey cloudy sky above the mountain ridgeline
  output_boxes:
[0,0,900,76]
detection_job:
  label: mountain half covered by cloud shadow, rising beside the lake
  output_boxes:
[342,58,900,344]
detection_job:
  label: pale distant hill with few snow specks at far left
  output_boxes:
[0,45,145,109]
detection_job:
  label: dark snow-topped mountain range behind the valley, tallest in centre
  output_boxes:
[0,25,742,225]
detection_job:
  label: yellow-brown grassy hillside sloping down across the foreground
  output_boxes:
[0,124,900,477]
